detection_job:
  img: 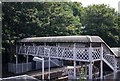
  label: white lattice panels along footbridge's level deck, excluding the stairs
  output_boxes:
[16,46,100,61]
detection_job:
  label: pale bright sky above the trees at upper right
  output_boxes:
[72,0,120,11]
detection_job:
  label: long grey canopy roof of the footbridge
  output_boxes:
[18,36,103,42]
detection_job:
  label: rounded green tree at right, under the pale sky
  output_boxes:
[82,4,120,46]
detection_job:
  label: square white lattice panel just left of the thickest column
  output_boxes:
[76,48,89,60]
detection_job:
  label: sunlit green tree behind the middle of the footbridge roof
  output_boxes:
[35,2,81,36]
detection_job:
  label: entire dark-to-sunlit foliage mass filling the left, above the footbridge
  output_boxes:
[2,2,81,62]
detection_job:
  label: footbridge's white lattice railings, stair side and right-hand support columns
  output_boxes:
[16,45,116,79]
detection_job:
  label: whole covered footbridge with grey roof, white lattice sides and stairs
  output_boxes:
[10,36,118,79]
